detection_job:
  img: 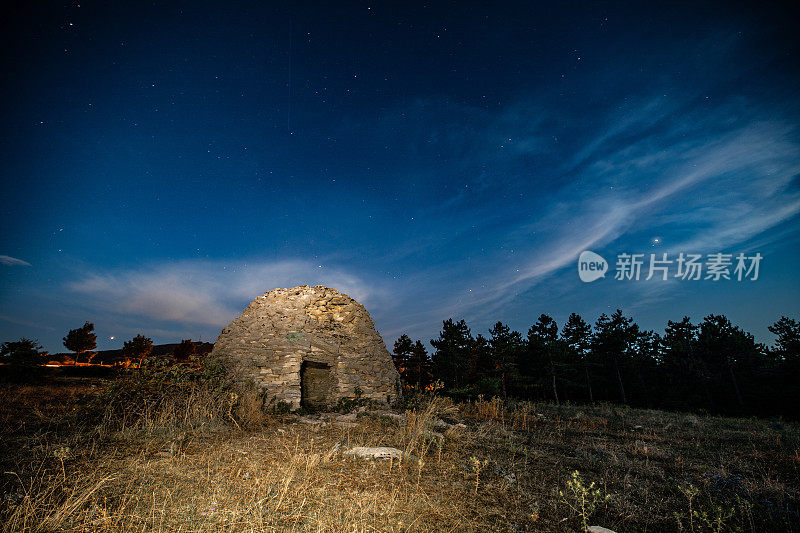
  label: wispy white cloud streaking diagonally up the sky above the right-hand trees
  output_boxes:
[406,94,800,324]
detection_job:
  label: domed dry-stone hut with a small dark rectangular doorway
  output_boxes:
[212,285,400,408]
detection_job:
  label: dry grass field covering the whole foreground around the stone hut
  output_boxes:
[0,372,800,532]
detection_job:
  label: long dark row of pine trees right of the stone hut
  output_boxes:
[392,309,800,418]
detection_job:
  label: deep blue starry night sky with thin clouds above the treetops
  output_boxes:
[0,1,800,352]
